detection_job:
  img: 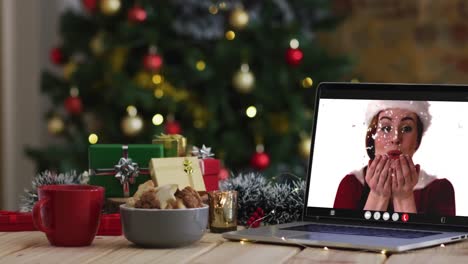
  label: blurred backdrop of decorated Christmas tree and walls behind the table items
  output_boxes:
[0,0,468,209]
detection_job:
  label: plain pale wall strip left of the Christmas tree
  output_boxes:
[1,0,40,210]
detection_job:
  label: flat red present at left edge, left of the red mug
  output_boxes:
[0,210,37,232]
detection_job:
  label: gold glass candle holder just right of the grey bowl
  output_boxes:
[208,191,237,233]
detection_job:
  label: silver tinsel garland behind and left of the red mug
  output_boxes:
[19,171,88,212]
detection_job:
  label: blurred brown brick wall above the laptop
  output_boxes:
[326,0,468,83]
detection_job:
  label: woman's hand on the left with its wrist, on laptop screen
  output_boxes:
[364,155,392,211]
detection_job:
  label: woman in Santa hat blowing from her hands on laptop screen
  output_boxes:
[334,101,455,216]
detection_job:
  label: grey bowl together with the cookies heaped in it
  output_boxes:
[120,181,209,248]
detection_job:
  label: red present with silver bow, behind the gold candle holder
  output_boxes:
[192,145,221,192]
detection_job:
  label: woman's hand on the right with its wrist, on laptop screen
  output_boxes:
[390,155,419,213]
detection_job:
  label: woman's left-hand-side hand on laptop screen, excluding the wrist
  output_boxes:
[366,155,392,198]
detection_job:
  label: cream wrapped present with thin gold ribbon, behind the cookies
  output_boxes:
[149,157,206,192]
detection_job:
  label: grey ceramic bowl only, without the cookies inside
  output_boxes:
[120,204,209,248]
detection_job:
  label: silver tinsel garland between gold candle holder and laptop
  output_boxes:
[220,173,305,225]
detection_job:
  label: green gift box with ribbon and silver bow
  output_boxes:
[88,144,164,198]
